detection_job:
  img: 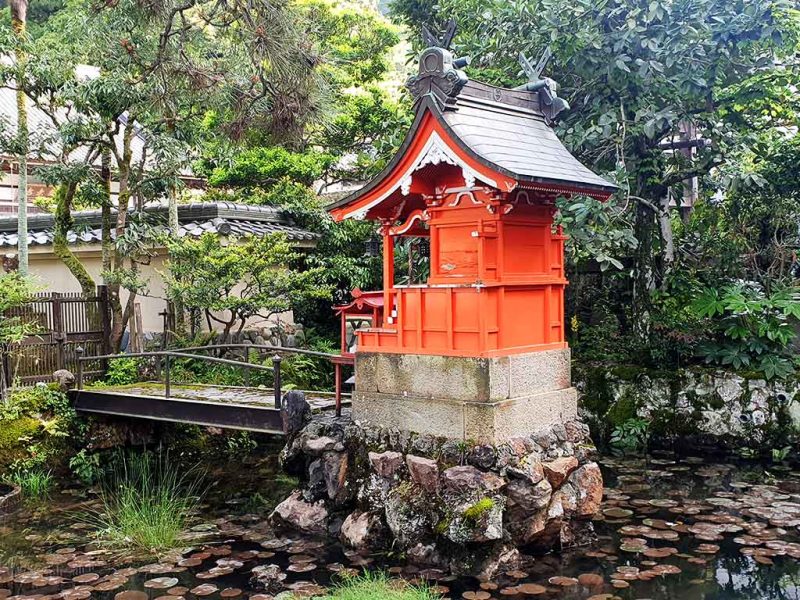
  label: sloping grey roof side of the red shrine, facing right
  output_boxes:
[439,81,616,192]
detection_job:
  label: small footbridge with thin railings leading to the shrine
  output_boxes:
[70,344,353,434]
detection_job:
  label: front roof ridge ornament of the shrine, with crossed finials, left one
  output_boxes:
[406,19,470,110]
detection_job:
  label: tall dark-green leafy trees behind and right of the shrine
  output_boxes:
[393,0,800,376]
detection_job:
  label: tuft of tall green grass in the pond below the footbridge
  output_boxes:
[92,453,200,553]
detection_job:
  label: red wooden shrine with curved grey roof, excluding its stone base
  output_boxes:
[330,41,615,366]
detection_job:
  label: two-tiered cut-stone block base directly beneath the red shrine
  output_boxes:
[353,349,578,444]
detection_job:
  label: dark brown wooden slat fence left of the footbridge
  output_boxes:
[0,286,111,386]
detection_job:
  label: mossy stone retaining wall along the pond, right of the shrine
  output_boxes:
[573,364,800,449]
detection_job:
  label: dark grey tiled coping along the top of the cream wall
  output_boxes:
[0,202,319,248]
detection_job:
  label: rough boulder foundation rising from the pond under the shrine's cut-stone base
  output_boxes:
[271,402,603,576]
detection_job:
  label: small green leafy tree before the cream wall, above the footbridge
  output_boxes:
[165,234,330,335]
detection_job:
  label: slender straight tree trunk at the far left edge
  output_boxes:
[9,0,29,275]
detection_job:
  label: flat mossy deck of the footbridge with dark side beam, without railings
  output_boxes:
[70,383,346,434]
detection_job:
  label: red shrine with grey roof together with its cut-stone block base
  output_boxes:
[329,36,616,443]
